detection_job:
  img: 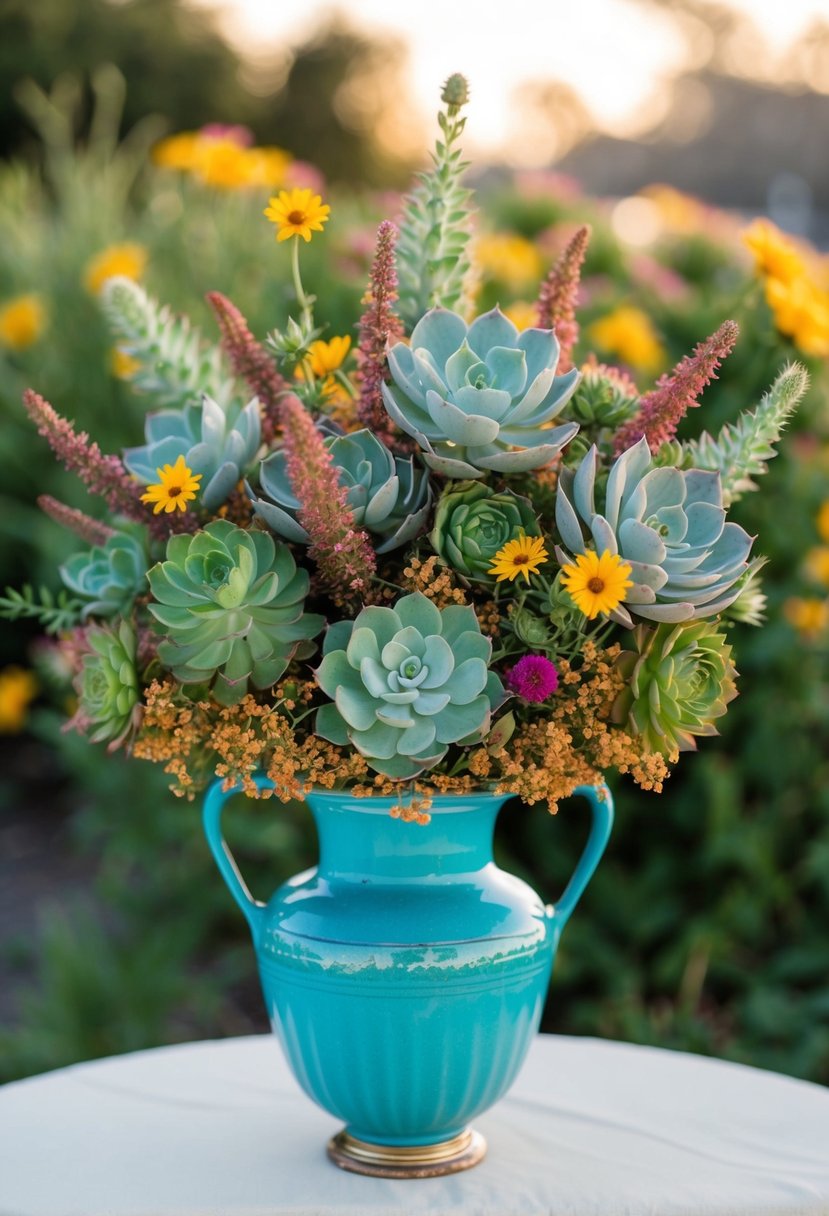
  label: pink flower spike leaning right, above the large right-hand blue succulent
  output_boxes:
[614,321,740,456]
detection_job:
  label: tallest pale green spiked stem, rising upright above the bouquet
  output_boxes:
[396,73,472,330]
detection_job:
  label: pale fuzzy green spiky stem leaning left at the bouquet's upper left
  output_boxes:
[101,277,235,409]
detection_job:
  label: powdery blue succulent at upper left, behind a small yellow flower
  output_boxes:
[124,396,261,511]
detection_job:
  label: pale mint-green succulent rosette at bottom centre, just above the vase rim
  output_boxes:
[315,591,503,779]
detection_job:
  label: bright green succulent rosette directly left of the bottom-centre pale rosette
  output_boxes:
[147,519,325,705]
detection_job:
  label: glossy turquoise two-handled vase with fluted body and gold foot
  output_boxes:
[204,777,613,1177]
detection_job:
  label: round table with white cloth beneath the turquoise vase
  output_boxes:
[0,1036,829,1216]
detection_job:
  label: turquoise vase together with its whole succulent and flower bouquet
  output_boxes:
[2,77,806,1176]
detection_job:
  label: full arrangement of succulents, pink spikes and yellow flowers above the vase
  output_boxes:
[0,75,807,817]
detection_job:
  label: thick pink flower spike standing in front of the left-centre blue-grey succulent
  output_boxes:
[280,393,377,607]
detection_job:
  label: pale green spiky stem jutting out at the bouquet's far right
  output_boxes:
[684,364,808,507]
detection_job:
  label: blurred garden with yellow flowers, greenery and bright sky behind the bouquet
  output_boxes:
[0,0,829,1083]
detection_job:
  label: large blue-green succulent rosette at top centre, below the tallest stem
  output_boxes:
[383,308,579,479]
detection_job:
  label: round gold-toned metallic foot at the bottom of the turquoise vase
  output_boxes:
[328,1128,486,1178]
